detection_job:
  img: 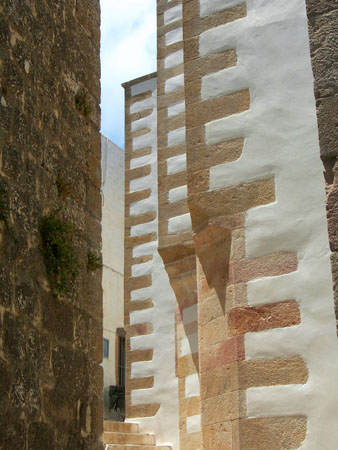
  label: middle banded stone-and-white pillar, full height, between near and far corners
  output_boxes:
[157,0,201,450]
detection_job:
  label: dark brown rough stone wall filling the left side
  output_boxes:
[0,0,103,450]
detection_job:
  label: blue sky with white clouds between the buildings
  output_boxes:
[100,0,156,148]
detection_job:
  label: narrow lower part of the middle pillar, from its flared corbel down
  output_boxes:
[160,239,201,450]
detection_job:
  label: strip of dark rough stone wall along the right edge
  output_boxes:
[306,0,338,329]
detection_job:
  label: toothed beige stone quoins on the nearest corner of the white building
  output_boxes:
[179,0,307,450]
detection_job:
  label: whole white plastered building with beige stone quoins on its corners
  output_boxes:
[124,0,338,450]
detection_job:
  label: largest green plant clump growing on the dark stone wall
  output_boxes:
[40,213,79,295]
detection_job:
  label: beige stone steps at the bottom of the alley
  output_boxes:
[103,420,171,450]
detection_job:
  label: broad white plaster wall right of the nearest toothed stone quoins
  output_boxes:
[200,0,338,450]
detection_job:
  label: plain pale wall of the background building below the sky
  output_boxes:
[101,136,124,419]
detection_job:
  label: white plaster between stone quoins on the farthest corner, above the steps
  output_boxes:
[130,75,179,450]
